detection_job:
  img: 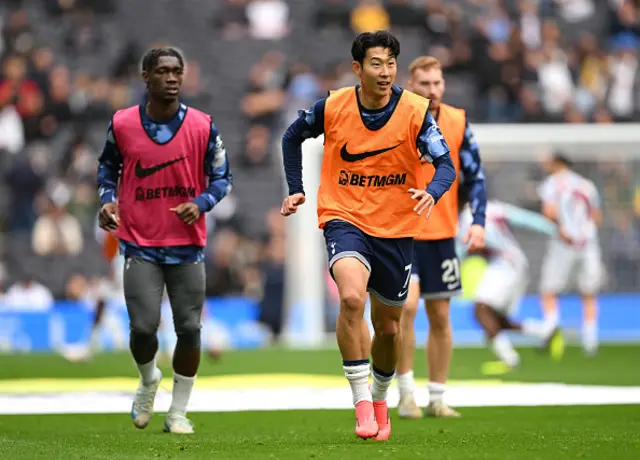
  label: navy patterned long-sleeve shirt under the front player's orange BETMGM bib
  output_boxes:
[282,85,456,203]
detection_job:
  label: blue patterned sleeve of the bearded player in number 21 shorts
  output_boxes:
[460,122,487,227]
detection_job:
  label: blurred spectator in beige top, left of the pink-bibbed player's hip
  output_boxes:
[31,184,83,256]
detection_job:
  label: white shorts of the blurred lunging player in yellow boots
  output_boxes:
[474,259,527,316]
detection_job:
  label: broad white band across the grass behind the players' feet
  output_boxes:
[0,383,640,414]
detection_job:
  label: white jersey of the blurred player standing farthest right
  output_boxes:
[538,169,600,246]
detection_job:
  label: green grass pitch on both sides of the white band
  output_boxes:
[0,346,640,460]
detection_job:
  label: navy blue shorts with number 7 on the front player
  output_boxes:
[324,220,413,307]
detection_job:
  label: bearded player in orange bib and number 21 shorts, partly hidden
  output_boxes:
[398,56,487,418]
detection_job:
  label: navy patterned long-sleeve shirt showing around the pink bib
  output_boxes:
[98,104,233,264]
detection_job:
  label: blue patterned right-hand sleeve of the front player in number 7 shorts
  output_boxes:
[416,110,456,203]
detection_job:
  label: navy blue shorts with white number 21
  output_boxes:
[411,238,462,300]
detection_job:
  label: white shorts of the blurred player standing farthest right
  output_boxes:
[540,240,604,294]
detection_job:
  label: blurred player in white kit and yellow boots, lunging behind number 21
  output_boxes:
[458,200,562,373]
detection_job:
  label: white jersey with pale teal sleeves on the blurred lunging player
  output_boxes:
[458,200,555,269]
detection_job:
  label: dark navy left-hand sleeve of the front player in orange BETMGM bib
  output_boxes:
[282,99,326,195]
